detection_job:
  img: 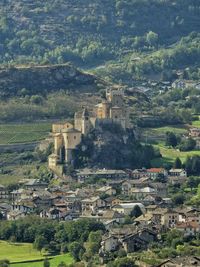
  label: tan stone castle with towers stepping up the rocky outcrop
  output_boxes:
[49,90,130,174]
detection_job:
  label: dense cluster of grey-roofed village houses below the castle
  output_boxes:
[0,168,200,266]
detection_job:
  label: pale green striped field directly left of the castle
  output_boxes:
[0,122,51,144]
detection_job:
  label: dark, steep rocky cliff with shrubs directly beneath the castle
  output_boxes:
[74,124,155,169]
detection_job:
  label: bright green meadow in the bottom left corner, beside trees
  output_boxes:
[0,241,73,267]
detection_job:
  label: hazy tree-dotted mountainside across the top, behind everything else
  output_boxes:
[0,0,200,80]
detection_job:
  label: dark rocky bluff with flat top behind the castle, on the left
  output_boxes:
[0,64,103,97]
